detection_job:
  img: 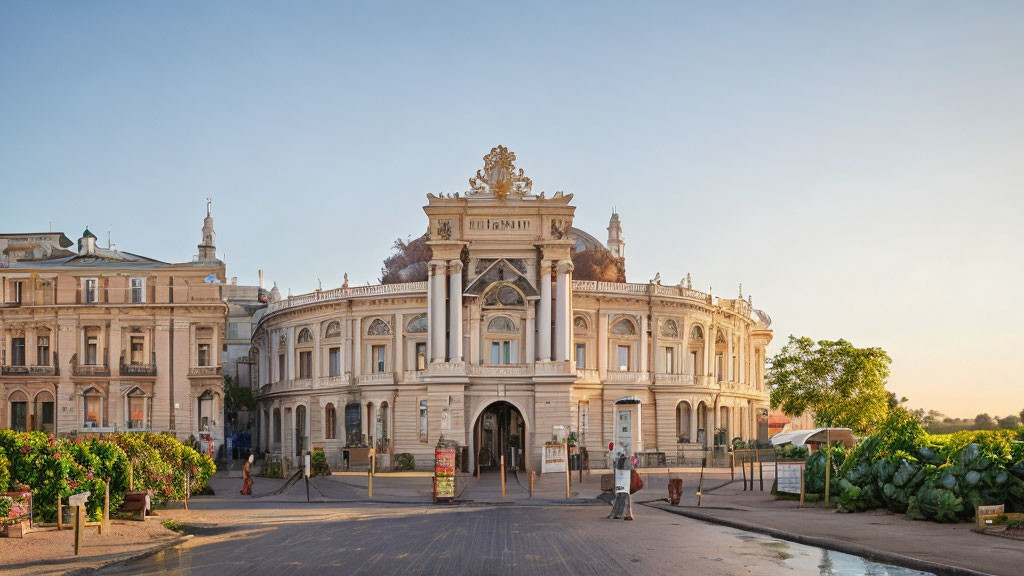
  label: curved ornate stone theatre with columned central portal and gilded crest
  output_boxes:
[252,147,772,470]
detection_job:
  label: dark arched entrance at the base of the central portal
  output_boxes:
[473,401,526,470]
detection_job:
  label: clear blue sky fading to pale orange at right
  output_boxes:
[0,1,1024,416]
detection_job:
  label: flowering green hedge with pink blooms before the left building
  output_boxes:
[0,430,216,522]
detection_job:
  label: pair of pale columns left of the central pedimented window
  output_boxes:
[427,260,463,363]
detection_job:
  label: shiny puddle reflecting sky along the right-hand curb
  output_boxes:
[735,531,935,576]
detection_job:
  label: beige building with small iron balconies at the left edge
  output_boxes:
[0,205,226,444]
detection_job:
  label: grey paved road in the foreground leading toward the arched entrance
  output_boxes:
[100,498,929,576]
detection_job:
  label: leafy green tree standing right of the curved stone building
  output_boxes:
[767,335,892,435]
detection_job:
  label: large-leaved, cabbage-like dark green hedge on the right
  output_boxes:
[838,410,1024,522]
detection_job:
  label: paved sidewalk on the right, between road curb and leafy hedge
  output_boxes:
[634,468,1024,575]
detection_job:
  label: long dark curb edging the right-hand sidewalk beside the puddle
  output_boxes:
[642,502,990,576]
